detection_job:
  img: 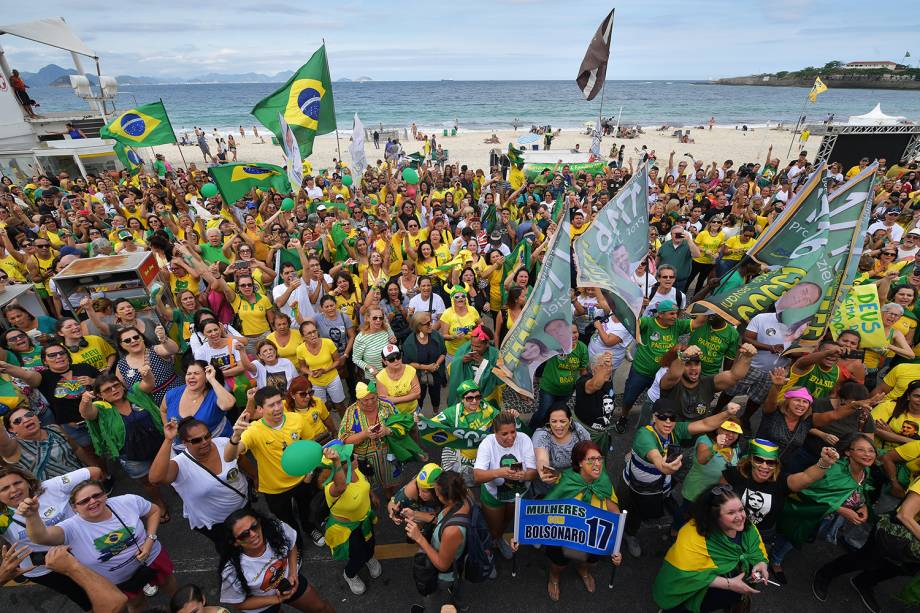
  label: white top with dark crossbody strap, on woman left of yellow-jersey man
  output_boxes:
[172,437,249,528]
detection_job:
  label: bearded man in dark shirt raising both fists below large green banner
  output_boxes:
[661,343,757,421]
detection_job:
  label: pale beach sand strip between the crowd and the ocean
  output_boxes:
[165,126,804,172]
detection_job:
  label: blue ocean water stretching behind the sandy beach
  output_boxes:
[30,81,920,132]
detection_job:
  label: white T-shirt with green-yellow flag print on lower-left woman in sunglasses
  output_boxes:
[60,494,162,585]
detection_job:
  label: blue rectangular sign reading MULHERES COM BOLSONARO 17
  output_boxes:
[514,496,626,556]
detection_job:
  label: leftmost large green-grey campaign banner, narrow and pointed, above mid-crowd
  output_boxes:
[492,211,572,398]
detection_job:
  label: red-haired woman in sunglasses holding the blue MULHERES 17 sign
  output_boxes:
[512,441,623,602]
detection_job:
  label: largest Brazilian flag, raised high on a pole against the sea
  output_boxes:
[252,45,336,158]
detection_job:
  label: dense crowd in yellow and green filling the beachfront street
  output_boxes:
[0,133,920,613]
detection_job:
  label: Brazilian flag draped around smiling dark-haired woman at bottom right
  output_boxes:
[652,521,767,613]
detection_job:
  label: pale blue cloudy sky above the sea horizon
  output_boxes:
[0,0,920,80]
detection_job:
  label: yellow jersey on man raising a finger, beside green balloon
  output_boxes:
[240,412,312,494]
